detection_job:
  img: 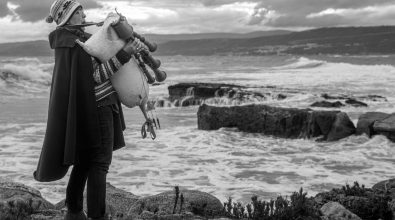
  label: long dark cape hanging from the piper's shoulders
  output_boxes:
[33,28,125,182]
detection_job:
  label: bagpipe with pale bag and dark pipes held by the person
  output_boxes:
[73,12,167,139]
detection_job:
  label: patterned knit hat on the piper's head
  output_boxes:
[46,0,82,27]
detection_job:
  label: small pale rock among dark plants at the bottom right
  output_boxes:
[321,202,362,220]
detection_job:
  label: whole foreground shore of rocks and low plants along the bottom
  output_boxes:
[0,179,395,220]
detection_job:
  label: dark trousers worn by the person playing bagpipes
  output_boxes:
[66,105,114,218]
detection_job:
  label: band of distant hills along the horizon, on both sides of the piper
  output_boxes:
[0,26,395,56]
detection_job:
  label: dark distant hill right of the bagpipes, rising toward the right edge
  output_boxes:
[158,26,395,55]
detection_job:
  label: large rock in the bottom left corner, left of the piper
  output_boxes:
[0,182,54,220]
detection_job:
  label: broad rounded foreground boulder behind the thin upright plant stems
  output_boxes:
[128,190,223,216]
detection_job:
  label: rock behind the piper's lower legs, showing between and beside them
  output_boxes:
[56,183,139,217]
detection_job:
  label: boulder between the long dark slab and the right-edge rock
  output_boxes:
[356,112,389,137]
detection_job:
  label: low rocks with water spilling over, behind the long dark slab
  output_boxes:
[155,82,387,108]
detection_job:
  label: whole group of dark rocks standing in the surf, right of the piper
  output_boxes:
[152,83,395,141]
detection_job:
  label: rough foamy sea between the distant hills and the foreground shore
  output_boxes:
[0,55,395,203]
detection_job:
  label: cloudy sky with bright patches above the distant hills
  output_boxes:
[0,0,395,43]
